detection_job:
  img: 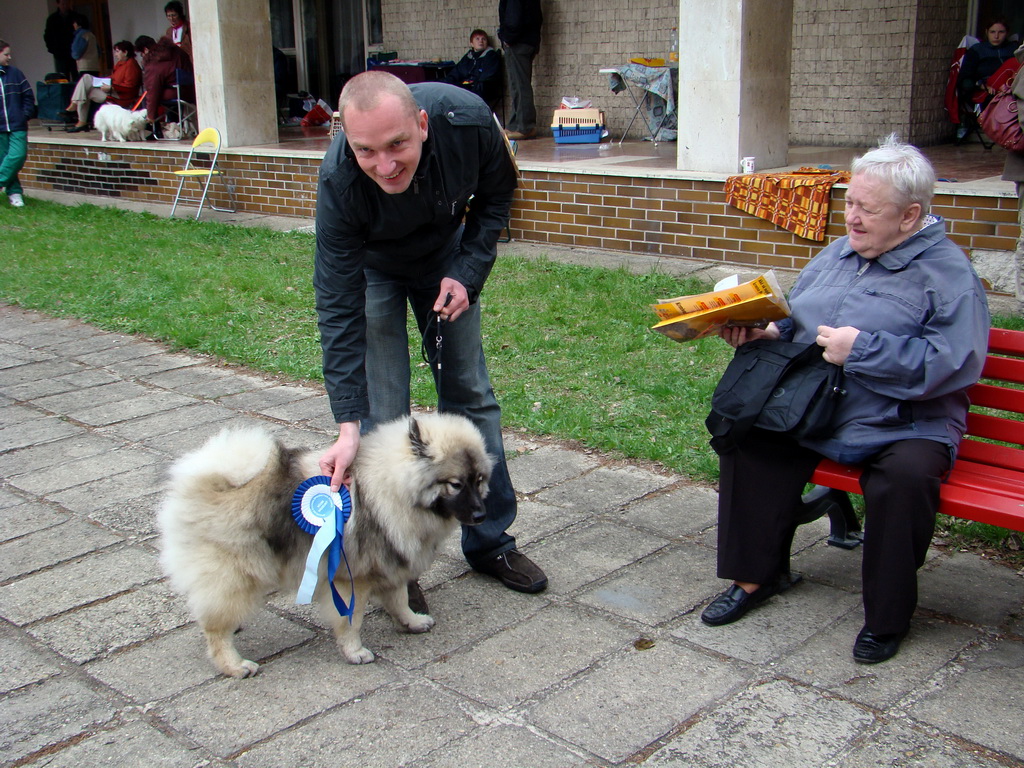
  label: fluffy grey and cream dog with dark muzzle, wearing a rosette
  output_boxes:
[158,413,494,678]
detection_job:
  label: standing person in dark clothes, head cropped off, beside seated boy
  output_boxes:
[498,0,544,140]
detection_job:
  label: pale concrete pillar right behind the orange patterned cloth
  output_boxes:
[677,0,793,173]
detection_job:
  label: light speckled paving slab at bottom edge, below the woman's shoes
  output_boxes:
[644,680,876,768]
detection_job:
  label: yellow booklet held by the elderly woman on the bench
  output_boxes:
[651,269,790,341]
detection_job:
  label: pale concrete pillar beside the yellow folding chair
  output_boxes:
[188,0,278,146]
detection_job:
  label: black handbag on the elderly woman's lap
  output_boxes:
[705,339,846,455]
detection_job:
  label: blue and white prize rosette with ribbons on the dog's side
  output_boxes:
[292,475,355,622]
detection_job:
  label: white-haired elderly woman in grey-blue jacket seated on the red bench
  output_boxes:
[701,136,989,664]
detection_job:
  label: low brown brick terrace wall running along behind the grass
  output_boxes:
[22,141,1020,292]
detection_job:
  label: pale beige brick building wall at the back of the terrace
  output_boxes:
[382,0,967,146]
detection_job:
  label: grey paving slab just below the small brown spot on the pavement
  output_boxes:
[524,641,749,763]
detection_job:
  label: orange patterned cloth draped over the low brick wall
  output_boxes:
[725,168,850,242]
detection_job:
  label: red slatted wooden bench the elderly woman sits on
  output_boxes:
[801,328,1024,549]
